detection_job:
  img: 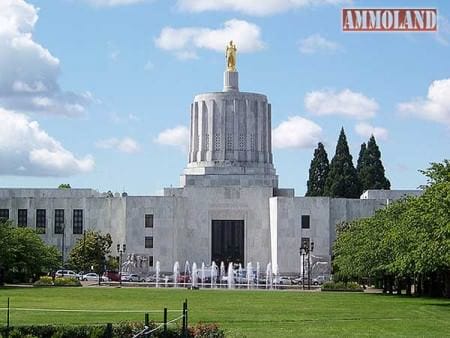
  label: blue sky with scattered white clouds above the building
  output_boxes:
[0,0,450,195]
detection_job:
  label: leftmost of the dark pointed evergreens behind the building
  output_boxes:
[305,142,330,196]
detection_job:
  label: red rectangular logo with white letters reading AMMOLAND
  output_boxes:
[342,8,437,32]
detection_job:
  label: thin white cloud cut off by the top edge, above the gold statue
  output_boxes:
[178,0,350,16]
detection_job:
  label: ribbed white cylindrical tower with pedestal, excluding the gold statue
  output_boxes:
[182,46,277,187]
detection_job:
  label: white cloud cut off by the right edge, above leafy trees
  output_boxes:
[398,78,450,127]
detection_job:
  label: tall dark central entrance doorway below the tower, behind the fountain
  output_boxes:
[211,220,244,265]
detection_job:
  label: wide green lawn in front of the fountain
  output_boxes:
[0,287,450,337]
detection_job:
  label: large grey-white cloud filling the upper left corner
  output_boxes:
[0,0,91,116]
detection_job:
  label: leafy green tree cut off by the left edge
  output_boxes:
[0,221,60,283]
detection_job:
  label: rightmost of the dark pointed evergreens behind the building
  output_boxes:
[358,135,391,191]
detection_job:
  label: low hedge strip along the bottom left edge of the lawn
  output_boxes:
[0,322,225,338]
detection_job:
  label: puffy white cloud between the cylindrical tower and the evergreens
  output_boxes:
[272,116,322,149]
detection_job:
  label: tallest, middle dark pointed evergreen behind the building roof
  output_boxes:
[325,128,360,198]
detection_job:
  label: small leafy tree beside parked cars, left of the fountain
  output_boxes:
[68,230,112,274]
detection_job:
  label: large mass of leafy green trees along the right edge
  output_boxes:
[333,160,450,297]
